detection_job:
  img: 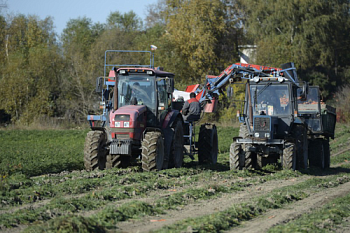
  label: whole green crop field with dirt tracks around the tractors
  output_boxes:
[0,125,350,232]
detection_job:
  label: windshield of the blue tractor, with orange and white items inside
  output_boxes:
[250,83,291,116]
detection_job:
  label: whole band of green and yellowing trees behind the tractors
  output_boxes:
[0,0,350,125]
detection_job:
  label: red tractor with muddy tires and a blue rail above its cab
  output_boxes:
[84,50,218,171]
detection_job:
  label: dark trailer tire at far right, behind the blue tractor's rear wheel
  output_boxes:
[309,138,325,169]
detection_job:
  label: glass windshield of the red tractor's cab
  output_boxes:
[118,75,157,110]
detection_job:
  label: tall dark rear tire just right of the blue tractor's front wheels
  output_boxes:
[293,125,309,170]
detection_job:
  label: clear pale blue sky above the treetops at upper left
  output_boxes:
[0,0,158,35]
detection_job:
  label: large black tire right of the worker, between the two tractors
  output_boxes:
[198,123,219,164]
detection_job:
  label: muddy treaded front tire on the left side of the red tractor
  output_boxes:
[84,131,107,171]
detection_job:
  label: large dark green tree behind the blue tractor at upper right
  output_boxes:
[238,0,350,98]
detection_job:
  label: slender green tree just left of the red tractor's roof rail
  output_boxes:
[59,17,105,122]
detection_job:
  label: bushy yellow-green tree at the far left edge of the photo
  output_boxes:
[0,15,62,124]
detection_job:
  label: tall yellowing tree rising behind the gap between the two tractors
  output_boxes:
[165,0,225,81]
